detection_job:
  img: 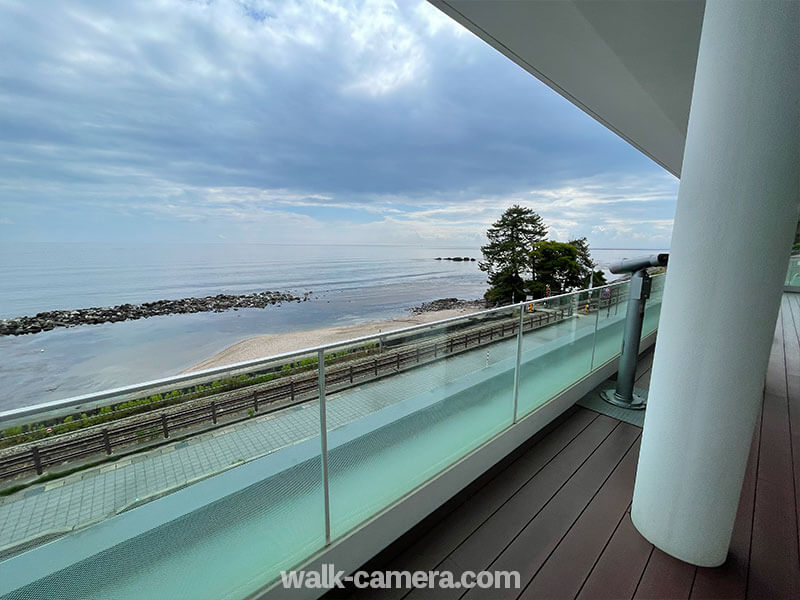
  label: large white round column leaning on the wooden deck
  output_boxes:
[631,0,800,566]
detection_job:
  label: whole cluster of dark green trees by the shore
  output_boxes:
[479,205,606,304]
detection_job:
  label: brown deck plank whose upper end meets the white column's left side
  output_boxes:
[520,442,639,599]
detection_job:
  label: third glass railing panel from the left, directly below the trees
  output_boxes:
[518,293,596,416]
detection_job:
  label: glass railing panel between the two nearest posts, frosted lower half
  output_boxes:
[326,308,519,538]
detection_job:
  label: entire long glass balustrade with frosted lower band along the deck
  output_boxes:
[0,275,664,598]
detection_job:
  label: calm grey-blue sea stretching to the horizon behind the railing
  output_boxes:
[0,243,663,412]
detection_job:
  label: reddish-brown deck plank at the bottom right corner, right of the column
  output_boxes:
[747,304,800,598]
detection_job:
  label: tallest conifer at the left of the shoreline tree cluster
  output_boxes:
[479,205,547,302]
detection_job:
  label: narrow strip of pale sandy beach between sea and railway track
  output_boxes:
[182,308,480,373]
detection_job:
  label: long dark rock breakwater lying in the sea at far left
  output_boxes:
[0,292,312,335]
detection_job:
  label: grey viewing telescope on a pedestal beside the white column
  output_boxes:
[601,253,669,409]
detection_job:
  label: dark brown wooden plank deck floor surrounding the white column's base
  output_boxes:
[340,294,800,599]
